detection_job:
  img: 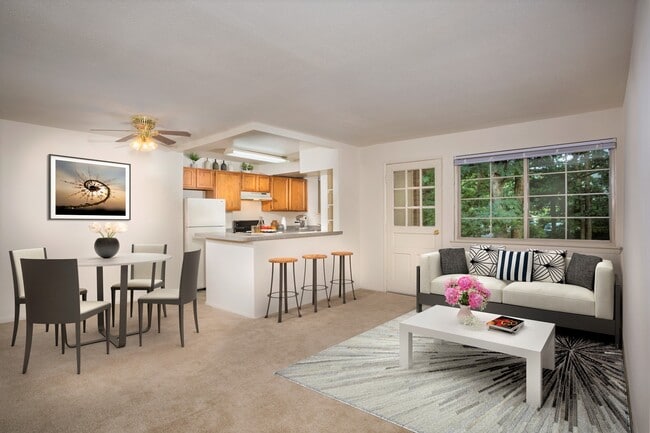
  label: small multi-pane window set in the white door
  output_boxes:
[393,168,436,227]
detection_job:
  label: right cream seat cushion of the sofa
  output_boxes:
[502,281,596,316]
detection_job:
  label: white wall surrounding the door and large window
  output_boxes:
[358,109,625,296]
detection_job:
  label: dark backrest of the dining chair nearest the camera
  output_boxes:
[21,259,81,323]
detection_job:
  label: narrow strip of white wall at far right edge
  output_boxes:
[623,0,650,433]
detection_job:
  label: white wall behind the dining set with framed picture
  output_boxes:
[0,120,183,322]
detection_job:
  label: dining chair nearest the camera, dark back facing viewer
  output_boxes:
[21,259,111,374]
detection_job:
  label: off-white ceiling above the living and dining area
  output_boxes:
[0,0,634,153]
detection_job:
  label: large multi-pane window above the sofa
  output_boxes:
[455,139,616,241]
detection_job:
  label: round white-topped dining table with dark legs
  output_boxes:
[77,253,172,347]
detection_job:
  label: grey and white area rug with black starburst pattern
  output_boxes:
[276,312,630,433]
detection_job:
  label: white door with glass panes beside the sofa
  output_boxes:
[385,160,441,295]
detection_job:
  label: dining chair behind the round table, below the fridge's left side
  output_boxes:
[111,244,167,326]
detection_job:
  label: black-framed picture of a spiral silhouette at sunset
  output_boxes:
[49,154,131,220]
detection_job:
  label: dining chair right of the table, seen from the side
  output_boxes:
[138,250,201,347]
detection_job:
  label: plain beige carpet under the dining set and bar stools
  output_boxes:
[0,290,415,433]
